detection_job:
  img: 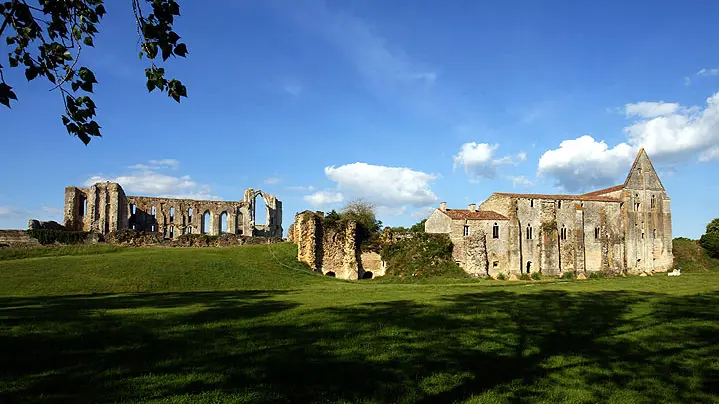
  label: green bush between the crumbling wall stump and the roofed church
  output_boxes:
[380,233,468,279]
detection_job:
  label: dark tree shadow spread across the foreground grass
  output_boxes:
[0,291,719,403]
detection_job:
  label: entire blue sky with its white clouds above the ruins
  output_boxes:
[0,0,719,238]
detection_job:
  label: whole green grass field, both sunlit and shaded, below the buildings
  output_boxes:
[0,244,719,403]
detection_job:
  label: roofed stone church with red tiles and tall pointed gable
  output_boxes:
[425,149,673,275]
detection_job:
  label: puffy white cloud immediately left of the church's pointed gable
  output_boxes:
[537,135,635,192]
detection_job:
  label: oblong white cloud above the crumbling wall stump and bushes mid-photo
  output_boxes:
[325,163,437,208]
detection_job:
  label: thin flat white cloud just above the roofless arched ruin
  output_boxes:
[85,159,221,200]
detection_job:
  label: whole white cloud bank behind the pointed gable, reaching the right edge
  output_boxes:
[537,93,719,191]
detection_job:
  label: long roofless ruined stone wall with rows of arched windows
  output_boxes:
[64,182,282,240]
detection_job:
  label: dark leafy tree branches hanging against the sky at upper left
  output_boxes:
[0,0,188,144]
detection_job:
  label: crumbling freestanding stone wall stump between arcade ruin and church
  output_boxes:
[287,211,386,280]
